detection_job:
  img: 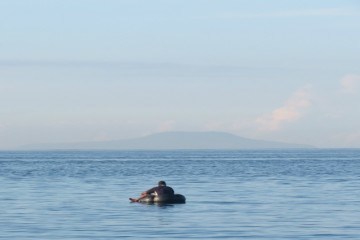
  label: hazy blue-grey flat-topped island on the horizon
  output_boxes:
[22,132,313,150]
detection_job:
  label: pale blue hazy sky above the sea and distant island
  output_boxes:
[0,0,360,150]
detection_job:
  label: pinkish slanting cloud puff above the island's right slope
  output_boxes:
[256,86,311,131]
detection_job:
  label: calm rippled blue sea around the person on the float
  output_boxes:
[0,149,360,240]
